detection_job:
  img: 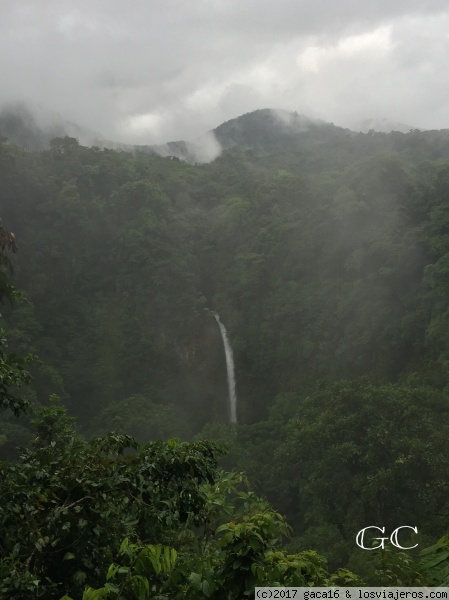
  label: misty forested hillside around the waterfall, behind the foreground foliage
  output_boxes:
[0,111,449,576]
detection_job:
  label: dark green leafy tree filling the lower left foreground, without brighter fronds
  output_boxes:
[0,406,224,599]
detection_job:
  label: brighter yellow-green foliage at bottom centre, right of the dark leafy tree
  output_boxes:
[67,493,361,600]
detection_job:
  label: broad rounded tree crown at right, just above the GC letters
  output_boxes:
[277,379,449,560]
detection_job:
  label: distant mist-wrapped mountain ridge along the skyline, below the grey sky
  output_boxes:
[5,104,449,163]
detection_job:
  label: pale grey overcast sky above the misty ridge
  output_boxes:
[0,0,449,143]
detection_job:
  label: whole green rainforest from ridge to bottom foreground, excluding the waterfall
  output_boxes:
[0,111,449,598]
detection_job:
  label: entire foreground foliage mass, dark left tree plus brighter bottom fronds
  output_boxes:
[0,406,364,600]
